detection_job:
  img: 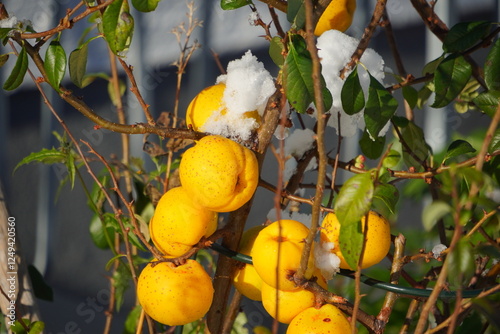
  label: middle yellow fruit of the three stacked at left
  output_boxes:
[149,187,218,256]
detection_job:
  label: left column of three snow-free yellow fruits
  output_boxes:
[137,136,259,326]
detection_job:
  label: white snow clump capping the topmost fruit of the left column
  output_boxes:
[204,50,276,140]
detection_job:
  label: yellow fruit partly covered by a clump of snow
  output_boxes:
[186,83,261,131]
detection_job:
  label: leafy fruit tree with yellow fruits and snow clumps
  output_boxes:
[0,0,500,334]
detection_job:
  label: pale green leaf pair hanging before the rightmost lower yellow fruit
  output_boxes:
[334,173,374,269]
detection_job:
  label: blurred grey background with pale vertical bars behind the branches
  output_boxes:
[0,0,500,333]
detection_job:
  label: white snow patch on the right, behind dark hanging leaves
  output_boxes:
[317,30,389,137]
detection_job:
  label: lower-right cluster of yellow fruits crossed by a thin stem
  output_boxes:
[233,211,391,334]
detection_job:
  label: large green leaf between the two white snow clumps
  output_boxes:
[283,35,332,113]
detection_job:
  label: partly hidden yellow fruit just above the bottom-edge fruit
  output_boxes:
[262,283,314,324]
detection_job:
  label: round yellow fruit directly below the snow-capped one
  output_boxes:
[179,136,259,212]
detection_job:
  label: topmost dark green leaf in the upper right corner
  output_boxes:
[443,21,491,53]
